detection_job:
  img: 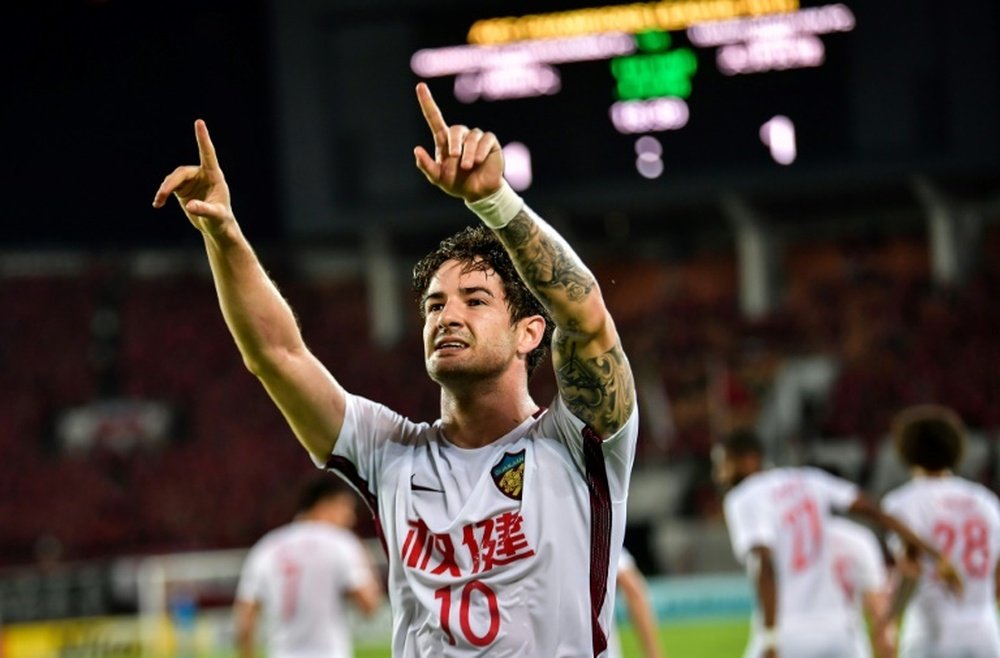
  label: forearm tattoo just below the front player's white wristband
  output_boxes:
[498,208,594,306]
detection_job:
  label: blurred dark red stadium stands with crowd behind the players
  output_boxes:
[0,214,1000,567]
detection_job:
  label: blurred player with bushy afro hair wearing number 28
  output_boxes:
[882,405,1000,658]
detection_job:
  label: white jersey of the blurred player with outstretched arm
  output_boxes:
[724,468,858,658]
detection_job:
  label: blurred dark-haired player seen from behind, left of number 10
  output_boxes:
[234,474,382,658]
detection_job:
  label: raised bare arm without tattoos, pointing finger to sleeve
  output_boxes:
[153,120,346,461]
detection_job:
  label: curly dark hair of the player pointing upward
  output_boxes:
[413,225,554,378]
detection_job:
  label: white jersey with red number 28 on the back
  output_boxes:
[882,476,1000,658]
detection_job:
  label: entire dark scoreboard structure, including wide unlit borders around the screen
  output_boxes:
[276,0,1000,234]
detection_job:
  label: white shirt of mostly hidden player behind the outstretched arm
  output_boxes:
[827,516,888,658]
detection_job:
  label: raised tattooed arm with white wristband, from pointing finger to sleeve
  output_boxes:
[414,83,636,438]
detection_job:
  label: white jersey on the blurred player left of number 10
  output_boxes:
[236,521,374,658]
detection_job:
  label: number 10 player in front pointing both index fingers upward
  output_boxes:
[153,83,638,657]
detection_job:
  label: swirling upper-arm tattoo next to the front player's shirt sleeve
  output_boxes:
[553,333,635,437]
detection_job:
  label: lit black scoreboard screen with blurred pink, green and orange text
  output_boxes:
[410,0,857,188]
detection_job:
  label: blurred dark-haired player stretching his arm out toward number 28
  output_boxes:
[713,430,961,658]
